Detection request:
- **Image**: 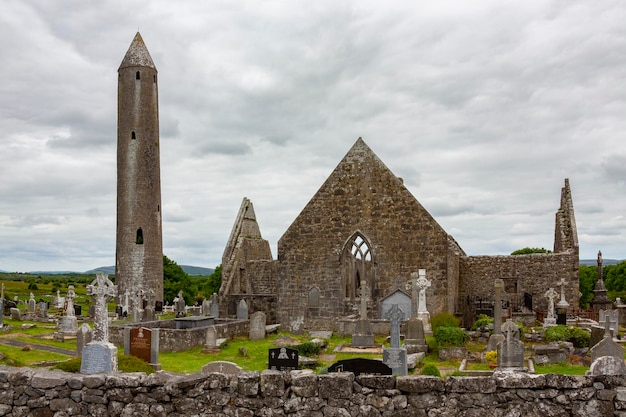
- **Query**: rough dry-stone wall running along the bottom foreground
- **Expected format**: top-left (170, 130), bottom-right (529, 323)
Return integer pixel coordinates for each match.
top-left (0, 367), bottom-right (626, 417)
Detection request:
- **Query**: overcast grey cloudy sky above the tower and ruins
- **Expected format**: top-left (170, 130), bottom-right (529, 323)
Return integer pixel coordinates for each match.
top-left (0, 0), bottom-right (626, 271)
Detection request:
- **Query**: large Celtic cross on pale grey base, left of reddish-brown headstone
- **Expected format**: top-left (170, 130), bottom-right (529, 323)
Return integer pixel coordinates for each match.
top-left (80, 274), bottom-right (117, 374)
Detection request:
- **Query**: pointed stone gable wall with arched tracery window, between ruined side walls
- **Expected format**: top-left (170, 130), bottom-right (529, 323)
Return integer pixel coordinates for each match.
top-left (278, 138), bottom-right (460, 324)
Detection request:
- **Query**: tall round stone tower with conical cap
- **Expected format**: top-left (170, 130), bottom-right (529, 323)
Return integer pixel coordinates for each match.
top-left (115, 33), bottom-right (163, 308)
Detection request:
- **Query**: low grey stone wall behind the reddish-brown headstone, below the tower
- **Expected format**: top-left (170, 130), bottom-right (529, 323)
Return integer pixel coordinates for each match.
top-left (109, 319), bottom-right (250, 352)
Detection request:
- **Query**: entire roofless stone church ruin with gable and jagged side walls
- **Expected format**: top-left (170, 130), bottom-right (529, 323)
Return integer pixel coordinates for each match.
top-left (220, 138), bottom-right (579, 331)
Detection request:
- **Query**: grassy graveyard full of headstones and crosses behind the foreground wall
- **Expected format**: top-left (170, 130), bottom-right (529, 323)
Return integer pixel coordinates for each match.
top-left (0, 275), bottom-right (624, 376)
